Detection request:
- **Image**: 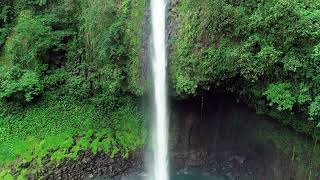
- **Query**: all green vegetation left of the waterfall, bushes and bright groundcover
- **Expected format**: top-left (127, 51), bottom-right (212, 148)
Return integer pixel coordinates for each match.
top-left (0, 0), bottom-right (146, 179)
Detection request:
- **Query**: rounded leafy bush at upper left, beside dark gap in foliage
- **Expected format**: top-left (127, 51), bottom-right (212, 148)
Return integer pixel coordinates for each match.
top-left (5, 11), bottom-right (65, 70)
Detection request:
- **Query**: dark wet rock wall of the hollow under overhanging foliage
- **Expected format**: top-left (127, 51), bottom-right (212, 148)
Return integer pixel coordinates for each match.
top-left (170, 94), bottom-right (312, 180)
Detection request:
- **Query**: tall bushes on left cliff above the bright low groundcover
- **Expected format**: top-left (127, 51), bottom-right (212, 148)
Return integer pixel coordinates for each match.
top-left (0, 0), bottom-right (145, 111)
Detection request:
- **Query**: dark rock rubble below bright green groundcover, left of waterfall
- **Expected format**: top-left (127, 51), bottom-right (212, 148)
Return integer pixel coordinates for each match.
top-left (34, 151), bottom-right (143, 180)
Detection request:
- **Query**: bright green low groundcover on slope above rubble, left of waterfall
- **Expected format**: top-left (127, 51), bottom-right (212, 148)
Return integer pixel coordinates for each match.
top-left (0, 97), bottom-right (146, 177)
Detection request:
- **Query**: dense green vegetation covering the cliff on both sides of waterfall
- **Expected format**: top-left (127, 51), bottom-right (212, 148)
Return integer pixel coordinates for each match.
top-left (0, 0), bottom-right (320, 179)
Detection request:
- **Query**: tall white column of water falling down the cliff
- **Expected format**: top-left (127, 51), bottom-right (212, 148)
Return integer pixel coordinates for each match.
top-left (151, 0), bottom-right (169, 180)
